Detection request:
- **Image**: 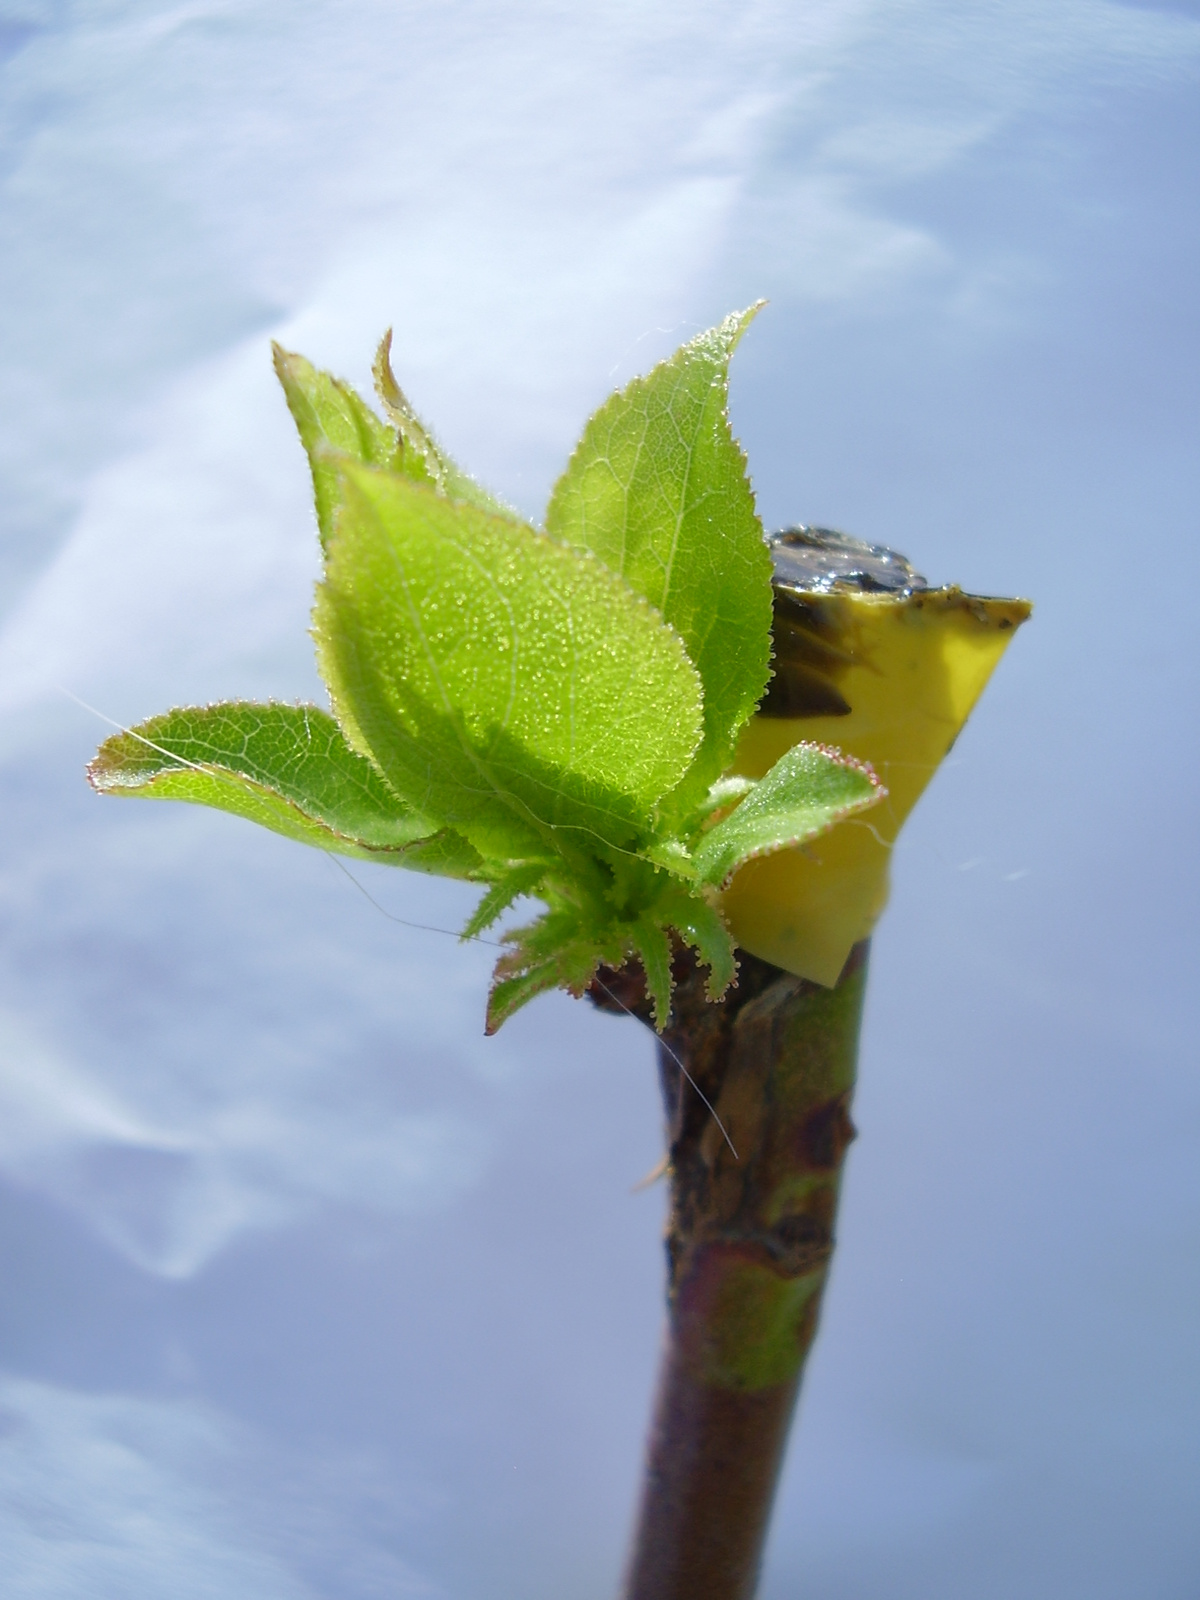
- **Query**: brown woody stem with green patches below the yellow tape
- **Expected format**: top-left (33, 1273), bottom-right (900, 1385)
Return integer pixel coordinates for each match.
top-left (594, 942), bottom-right (867, 1600)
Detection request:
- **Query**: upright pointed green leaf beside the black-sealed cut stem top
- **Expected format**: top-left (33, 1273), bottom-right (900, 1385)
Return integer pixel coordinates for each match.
top-left (546, 306), bottom-right (771, 806)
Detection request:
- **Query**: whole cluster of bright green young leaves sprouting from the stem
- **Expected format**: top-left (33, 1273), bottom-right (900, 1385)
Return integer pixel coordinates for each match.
top-left (90, 307), bottom-right (882, 1032)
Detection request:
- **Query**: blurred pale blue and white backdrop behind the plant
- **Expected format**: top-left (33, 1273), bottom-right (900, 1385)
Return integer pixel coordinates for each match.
top-left (0, 0), bottom-right (1200, 1600)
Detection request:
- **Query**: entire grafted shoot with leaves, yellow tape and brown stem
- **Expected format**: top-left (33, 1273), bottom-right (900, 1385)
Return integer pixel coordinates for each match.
top-left (88, 307), bottom-right (1029, 1600)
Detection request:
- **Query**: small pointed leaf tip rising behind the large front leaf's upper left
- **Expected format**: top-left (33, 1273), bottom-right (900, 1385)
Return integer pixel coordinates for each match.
top-left (270, 344), bottom-right (405, 547)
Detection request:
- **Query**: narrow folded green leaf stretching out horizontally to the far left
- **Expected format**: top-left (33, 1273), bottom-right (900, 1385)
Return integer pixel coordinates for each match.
top-left (88, 701), bottom-right (482, 877)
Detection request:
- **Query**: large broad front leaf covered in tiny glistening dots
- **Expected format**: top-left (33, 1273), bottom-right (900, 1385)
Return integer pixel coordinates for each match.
top-left (314, 464), bottom-right (701, 861)
